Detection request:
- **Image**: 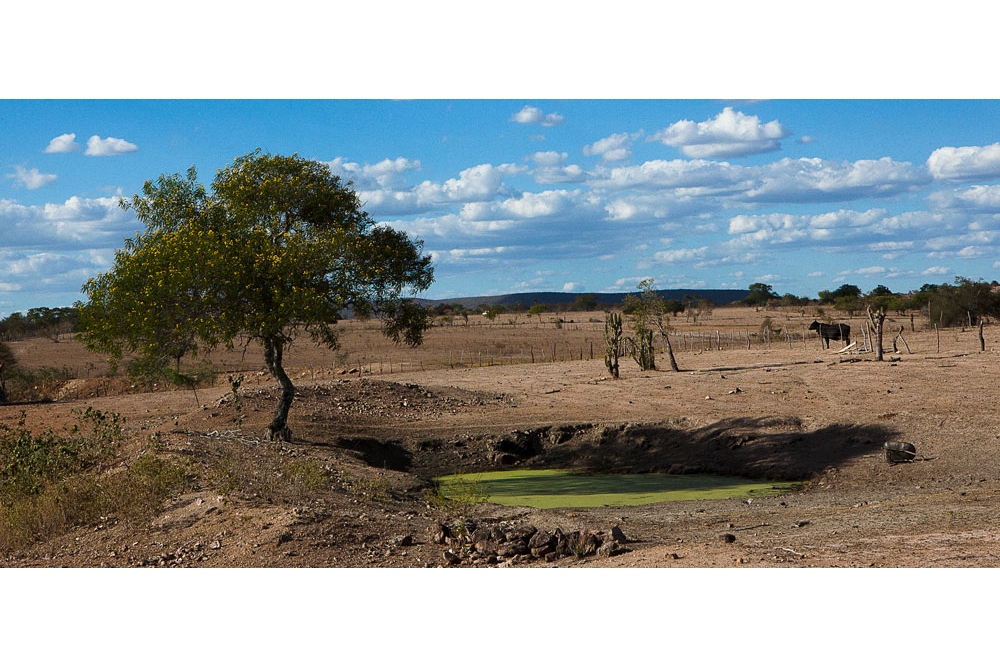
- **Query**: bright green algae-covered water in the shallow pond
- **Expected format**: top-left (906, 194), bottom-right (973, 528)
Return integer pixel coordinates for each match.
top-left (437, 470), bottom-right (799, 508)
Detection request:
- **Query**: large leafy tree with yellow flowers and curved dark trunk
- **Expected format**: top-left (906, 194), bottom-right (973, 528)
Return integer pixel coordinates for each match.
top-left (78, 150), bottom-right (433, 440)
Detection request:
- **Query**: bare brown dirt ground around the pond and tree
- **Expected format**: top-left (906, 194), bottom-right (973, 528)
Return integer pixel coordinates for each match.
top-left (0, 314), bottom-right (1000, 568)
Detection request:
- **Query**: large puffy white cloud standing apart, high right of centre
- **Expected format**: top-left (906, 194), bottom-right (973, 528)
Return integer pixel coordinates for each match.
top-left (649, 107), bottom-right (791, 158)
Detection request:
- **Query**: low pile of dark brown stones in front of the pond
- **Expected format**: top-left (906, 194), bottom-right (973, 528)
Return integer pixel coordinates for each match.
top-left (432, 519), bottom-right (628, 565)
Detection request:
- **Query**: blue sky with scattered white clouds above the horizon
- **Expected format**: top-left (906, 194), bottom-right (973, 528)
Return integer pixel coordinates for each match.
top-left (0, 99), bottom-right (1000, 316)
